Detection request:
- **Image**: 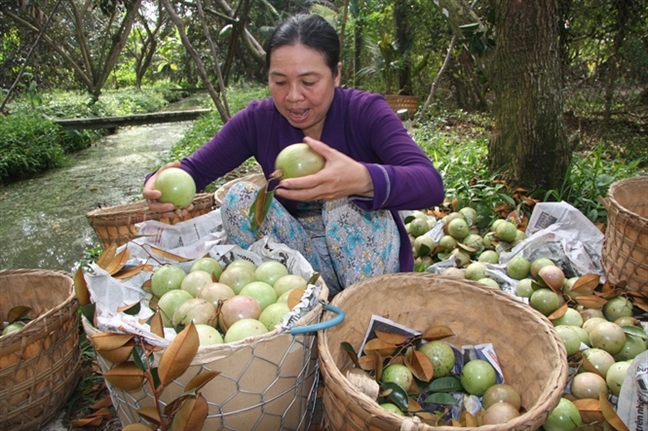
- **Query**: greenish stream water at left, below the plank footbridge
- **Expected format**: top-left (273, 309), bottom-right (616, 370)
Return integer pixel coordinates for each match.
top-left (0, 122), bottom-right (191, 271)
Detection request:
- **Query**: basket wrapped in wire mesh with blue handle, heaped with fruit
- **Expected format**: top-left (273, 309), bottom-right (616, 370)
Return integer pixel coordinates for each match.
top-left (83, 280), bottom-right (328, 431)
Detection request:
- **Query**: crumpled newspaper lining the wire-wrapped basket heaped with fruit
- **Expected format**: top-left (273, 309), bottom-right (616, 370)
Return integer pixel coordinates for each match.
top-left (85, 209), bottom-right (323, 347)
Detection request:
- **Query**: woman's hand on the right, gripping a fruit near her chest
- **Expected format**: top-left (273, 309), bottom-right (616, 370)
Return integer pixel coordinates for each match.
top-left (275, 138), bottom-right (373, 201)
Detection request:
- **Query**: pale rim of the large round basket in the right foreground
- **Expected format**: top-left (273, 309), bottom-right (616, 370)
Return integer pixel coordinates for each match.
top-left (317, 273), bottom-right (568, 431)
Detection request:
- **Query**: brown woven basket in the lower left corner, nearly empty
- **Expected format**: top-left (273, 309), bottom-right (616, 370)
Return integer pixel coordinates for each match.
top-left (0, 269), bottom-right (81, 431)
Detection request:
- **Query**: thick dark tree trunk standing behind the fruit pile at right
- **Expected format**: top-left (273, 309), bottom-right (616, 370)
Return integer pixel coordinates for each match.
top-left (489, 0), bottom-right (571, 189)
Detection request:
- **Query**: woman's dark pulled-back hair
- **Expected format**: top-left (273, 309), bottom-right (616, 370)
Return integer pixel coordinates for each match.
top-left (265, 13), bottom-right (340, 76)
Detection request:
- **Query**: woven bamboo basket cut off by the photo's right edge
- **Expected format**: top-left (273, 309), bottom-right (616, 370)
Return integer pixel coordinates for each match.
top-left (601, 176), bottom-right (648, 293)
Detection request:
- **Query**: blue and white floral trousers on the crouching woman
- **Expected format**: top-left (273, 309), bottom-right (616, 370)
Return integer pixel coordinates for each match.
top-left (221, 182), bottom-right (400, 296)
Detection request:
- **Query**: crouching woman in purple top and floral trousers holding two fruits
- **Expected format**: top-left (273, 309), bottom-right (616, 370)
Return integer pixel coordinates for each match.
top-left (143, 14), bottom-right (444, 294)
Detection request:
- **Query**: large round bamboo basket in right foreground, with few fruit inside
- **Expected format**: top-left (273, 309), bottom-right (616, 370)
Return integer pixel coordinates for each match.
top-left (318, 273), bottom-right (568, 431)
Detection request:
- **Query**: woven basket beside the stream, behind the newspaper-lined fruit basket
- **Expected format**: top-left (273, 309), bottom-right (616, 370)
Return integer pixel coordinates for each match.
top-left (86, 193), bottom-right (214, 250)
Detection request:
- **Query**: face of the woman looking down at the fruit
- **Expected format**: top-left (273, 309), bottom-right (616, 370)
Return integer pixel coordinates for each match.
top-left (268, 45), bottom-right (340, 139)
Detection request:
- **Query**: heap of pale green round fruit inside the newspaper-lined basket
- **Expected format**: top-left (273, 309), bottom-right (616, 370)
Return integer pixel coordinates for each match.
top-left (144, 257), bottom-right (308, 345)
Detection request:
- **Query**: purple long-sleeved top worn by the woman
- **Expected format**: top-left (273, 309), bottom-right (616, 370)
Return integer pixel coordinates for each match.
top-left (181, 87), bottom-right (444, 271)
